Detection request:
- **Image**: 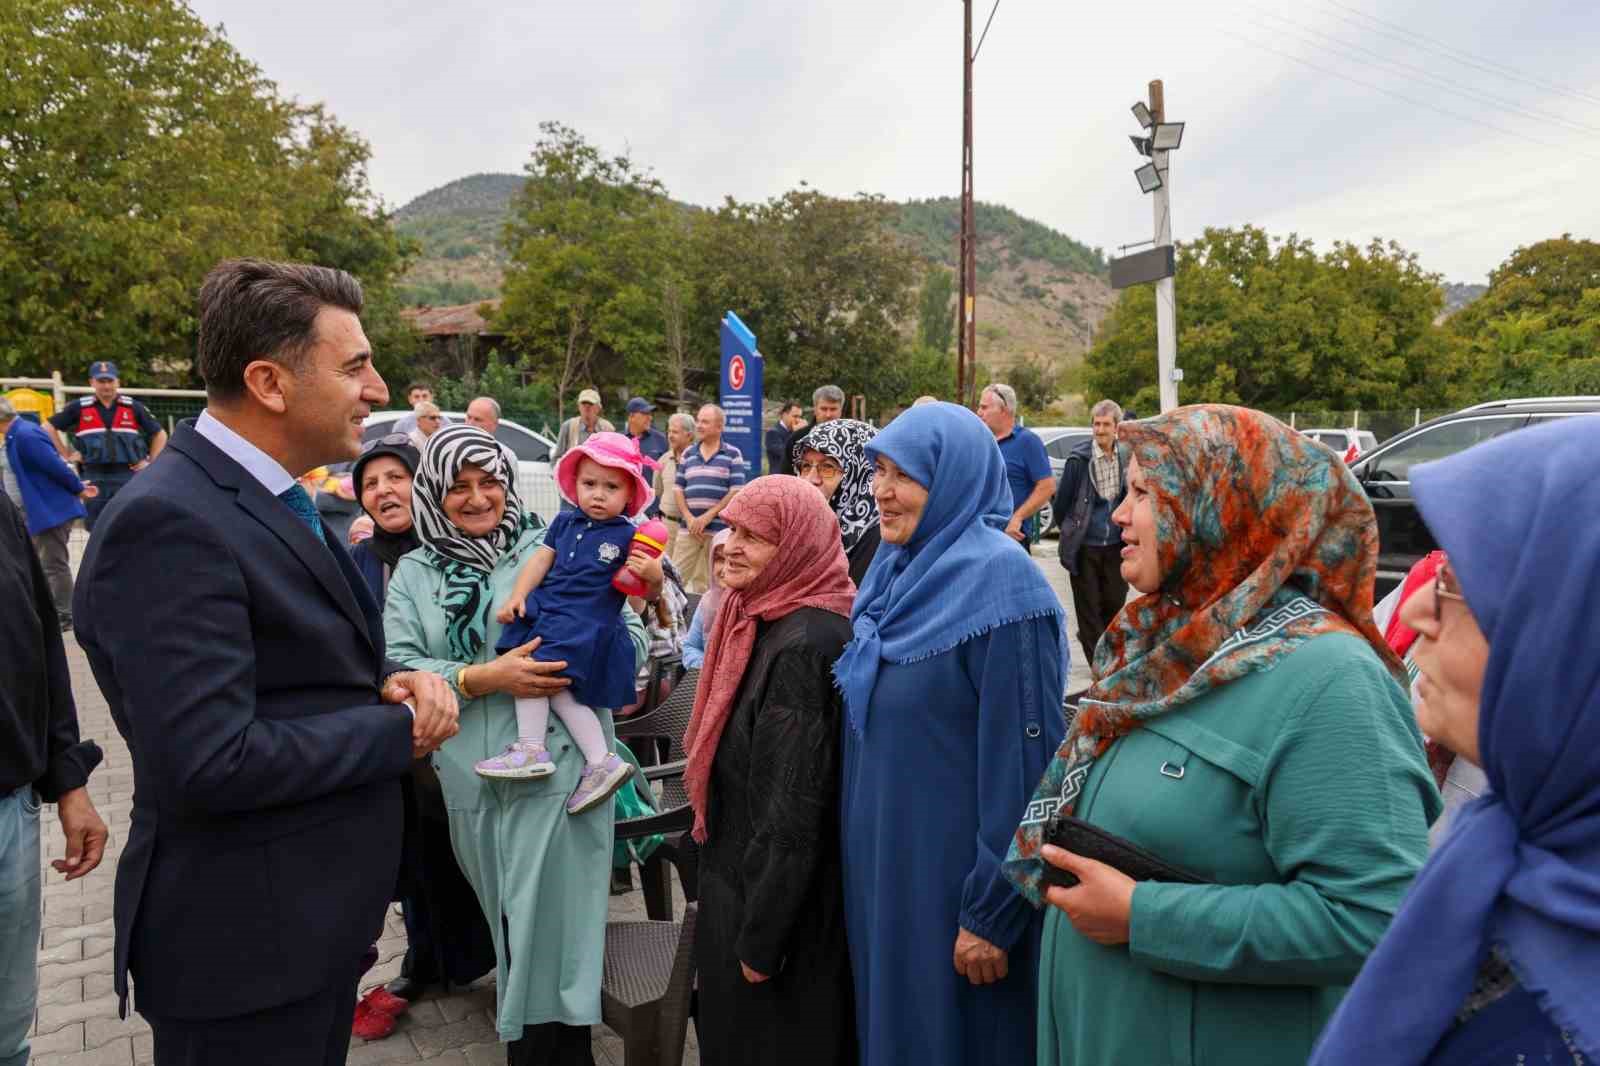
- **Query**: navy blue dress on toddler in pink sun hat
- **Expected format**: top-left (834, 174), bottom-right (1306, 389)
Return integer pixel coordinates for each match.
top-left (494, 511), bottom-right (637, 707)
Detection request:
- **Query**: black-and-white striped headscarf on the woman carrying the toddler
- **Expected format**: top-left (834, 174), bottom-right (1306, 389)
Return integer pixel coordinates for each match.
top-left (411, 426), bottom-right (538, 663)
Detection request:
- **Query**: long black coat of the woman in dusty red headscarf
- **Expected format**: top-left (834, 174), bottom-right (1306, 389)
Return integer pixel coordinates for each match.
top-left (694, 607), bottom-right (856, 1066)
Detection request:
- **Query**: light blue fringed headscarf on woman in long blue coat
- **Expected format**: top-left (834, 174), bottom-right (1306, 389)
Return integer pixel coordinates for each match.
top-left (834, 403), bottom-right (1067, 736)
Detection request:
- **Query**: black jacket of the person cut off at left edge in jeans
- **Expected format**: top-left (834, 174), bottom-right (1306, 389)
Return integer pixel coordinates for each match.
top-left (0, 493), bottom-right (101, 793)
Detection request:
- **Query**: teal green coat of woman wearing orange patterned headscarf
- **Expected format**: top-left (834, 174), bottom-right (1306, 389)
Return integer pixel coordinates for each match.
top-left (1038, 634), bottom-right (1440, 1066)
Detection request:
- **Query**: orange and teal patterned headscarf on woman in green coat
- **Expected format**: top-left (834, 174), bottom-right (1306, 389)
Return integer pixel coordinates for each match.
top-left (1003, 405), bottom-right (1405, 906)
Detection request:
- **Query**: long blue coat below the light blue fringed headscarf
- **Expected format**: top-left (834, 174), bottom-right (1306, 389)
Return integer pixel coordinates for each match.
top-left (842, 615), bottom-right (1066, 1066)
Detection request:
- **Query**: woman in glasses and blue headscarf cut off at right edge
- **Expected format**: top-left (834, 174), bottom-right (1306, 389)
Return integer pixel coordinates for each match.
top-left (1312, 418), bottom-right (1600, 1066)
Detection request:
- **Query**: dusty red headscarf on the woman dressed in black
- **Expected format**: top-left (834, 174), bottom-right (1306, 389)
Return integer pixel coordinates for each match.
top-left (683, 475), bottom-right (856, 842)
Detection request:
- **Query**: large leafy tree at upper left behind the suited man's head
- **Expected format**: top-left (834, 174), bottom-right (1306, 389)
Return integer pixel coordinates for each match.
top-left (0, 0), bottom-right (419, 383)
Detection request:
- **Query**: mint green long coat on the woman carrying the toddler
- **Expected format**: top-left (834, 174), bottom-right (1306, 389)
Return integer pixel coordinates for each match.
top-left (384, 530), bottom-right (646, 1040)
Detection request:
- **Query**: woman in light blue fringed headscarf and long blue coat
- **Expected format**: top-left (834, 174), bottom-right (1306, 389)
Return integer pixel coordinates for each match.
top-left (835, 403), bottom-right (1067, 1066)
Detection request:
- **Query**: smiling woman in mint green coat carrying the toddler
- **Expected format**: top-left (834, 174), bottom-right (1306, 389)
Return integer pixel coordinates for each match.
top-left (384, 426), bottom-right (645, 1066)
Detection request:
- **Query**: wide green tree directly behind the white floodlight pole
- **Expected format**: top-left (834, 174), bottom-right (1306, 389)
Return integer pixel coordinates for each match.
top-left (1085, 226), bottom-right (1453, 410)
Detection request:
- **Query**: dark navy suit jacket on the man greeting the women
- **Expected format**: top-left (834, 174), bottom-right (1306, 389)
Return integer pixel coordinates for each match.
top-left (74, 423), bottom-right (411, 1020)
